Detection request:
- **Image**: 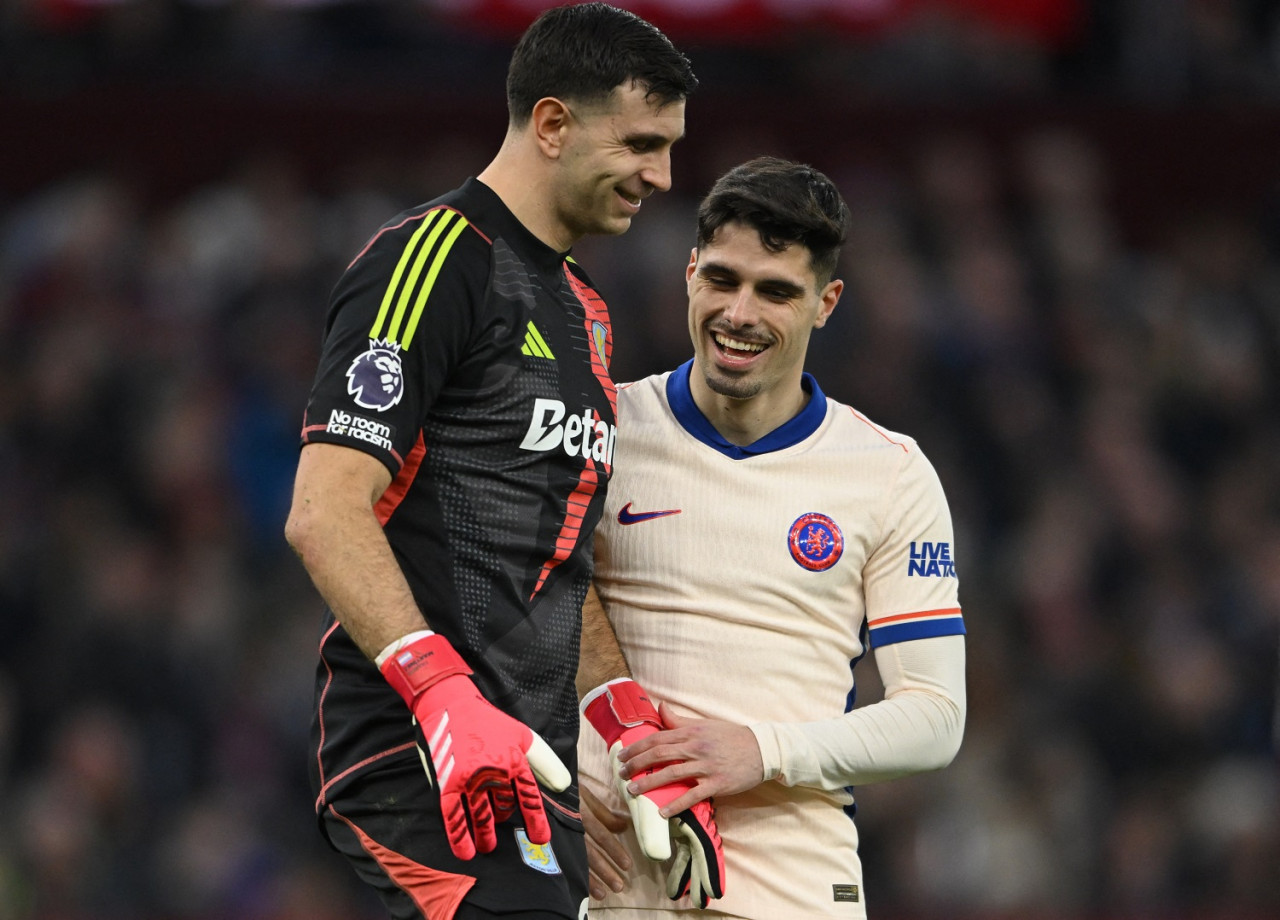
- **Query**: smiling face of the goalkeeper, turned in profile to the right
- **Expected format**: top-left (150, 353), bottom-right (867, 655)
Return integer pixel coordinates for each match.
top-left (552, 83), bottom-right (685, 242)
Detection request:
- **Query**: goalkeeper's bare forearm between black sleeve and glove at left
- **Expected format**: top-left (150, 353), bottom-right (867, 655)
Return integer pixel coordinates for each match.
top-left (284, 444), bottom-right (429, 660)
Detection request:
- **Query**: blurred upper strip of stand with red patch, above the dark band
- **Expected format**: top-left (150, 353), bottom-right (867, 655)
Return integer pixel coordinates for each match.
top-left (0, 0), bottom-right (1280, 101)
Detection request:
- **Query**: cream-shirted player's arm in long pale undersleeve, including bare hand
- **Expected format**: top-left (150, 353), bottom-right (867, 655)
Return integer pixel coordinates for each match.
top-left (618, 636), bottom-right (966, 813)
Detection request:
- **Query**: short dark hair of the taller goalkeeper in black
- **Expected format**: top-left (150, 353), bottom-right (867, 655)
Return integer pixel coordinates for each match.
top-left (507, 3), bottom-right (698, 125)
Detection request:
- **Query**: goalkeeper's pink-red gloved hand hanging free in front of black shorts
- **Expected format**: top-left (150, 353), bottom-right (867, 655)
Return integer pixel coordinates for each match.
top-left (378, 632), bottom-right (571, 860)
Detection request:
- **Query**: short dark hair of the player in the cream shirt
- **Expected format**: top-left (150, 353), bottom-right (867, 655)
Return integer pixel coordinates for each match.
top-left (698, 156), bottom-right (849, 287)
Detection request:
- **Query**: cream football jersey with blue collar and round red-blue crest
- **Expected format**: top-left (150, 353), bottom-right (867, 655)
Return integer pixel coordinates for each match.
top-left (579, 363), bottom-right (964, 917)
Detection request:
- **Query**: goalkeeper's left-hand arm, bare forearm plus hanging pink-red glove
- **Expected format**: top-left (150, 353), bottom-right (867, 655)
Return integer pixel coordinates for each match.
top-left (285, 444), bottom-right (572, 860)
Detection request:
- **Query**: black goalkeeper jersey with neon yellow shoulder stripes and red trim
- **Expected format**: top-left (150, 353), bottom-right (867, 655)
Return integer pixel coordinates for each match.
top-left (302, 179), bottom-right (616, 810)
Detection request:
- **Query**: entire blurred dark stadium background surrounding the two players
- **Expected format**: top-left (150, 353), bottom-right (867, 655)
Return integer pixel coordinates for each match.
top-left (0, 0), bottom-right (1280, 920)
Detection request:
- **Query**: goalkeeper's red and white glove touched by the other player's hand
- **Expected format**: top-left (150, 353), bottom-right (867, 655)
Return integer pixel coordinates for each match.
top-left (582, 678), bottom-right (724, 907)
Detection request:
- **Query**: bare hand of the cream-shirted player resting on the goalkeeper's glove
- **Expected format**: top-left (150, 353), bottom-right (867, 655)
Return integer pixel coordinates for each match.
top-left (617, 704), bottom-right (764, 816)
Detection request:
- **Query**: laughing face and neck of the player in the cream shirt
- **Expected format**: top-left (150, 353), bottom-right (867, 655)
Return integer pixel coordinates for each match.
top-left (686, 221), bottom-right (844, 440)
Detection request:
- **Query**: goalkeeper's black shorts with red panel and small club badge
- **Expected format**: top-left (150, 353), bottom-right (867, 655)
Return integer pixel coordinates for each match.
top-left (320, 759), bottom-right (588, 920)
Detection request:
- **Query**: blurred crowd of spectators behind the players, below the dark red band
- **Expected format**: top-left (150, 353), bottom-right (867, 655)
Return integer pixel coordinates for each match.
top-left (0, 3), bottom-right (1280, 920)
